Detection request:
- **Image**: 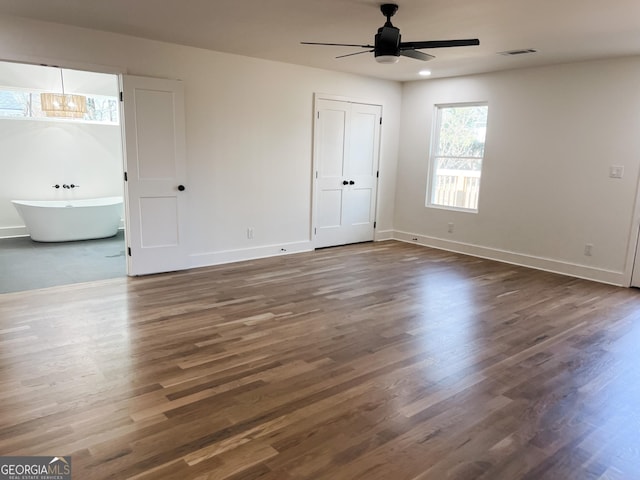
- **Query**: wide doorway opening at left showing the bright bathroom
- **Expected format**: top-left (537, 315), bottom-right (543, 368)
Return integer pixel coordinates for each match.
top-left (0, 62), bottom-right (127, 293)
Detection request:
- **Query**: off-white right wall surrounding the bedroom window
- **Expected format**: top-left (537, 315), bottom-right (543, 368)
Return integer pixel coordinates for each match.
top-left (395, 58), bottom-right (640, 284)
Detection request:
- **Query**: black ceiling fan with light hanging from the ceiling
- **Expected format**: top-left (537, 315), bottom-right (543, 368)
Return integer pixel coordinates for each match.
top-left (301, 3), bottom-right (480, 63)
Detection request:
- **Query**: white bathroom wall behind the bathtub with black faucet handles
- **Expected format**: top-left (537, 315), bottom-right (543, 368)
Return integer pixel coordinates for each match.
top-left (0, 118), bottom-right (123, 237)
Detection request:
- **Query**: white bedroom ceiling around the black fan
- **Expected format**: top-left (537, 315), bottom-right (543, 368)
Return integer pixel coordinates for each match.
top-left (0, 0), bottom-right (640, 81)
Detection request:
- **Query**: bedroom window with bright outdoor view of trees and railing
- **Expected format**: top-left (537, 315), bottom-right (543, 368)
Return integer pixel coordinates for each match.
top-left (427, 104), bottom-right (488, 212)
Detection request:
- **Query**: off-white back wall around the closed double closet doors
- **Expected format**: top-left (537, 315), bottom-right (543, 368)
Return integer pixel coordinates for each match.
top-left (0, 13), bottom-right (402, 265)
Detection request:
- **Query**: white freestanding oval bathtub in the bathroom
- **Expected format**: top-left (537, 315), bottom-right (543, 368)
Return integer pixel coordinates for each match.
top-left (11, 197), bottom-right (122, 242)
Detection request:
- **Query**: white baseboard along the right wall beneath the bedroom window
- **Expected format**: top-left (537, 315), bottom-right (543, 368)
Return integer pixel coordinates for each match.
top-left (393, 230), bottom-right (629, 287)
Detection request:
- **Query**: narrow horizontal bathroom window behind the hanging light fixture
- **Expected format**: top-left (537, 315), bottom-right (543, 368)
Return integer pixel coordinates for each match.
top-left (0, 90), bottom-right (119, 125)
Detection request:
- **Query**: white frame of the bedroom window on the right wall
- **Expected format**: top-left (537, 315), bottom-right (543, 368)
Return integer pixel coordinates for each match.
top-left (425, 101), bottom-right (489, 213)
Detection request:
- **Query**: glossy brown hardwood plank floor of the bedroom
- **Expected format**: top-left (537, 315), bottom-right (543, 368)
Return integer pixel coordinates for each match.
top-left (0, 242), bottom-right (640, 480)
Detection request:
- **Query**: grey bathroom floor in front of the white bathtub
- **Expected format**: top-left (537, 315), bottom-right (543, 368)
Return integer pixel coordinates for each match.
top-left (0, 230), bottom-right (126, 293)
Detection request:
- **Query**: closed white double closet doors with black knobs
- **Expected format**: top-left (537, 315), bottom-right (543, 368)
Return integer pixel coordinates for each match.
top-left (314, 99), bottom-right (382, 248)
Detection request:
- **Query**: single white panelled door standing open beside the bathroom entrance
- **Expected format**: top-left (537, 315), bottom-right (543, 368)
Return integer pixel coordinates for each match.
top-left (122, 75), bottom-right (188, 275)
